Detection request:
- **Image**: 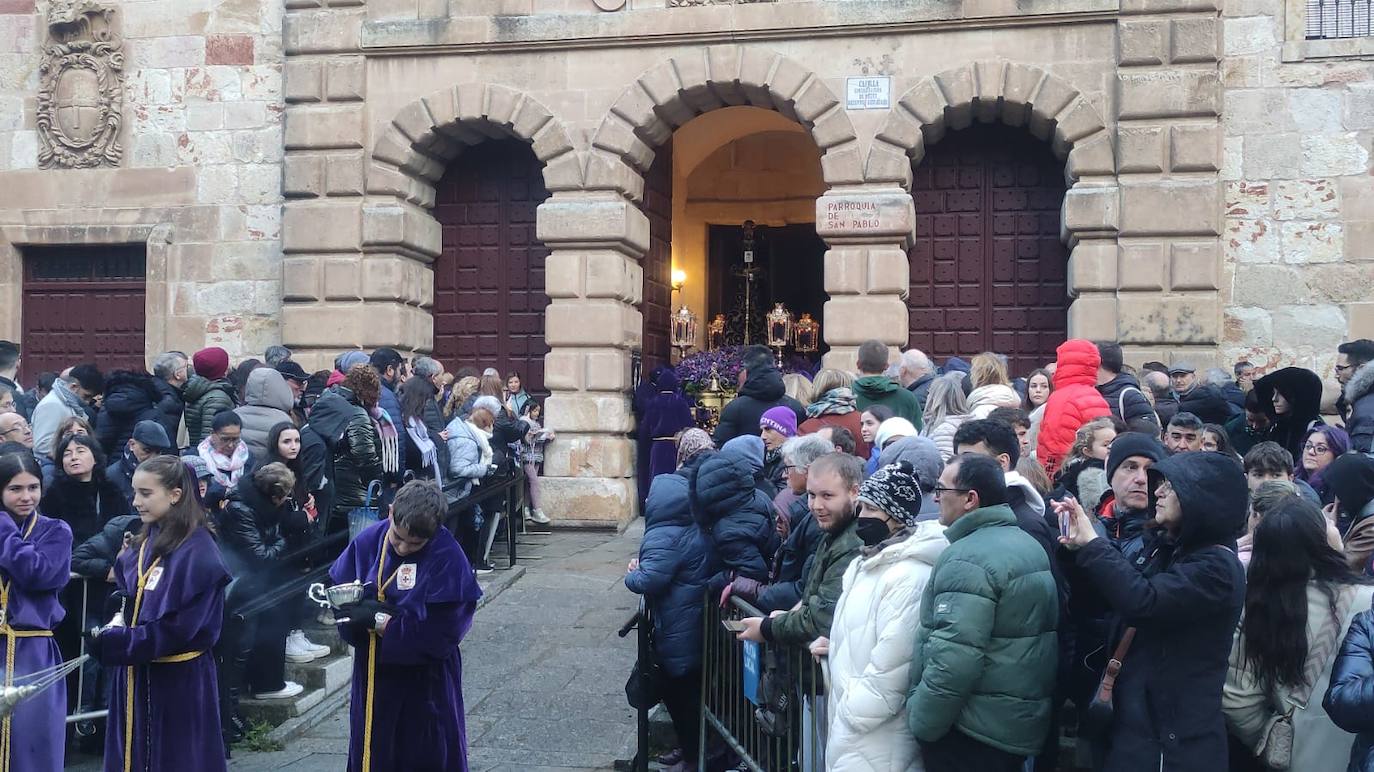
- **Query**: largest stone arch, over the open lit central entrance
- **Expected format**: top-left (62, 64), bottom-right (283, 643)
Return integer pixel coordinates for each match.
top-left (585, 45), bottom-right (863, 201)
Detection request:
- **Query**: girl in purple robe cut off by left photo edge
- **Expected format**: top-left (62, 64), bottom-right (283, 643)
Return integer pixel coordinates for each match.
top-left (0, 453), bottom-right (71, 772)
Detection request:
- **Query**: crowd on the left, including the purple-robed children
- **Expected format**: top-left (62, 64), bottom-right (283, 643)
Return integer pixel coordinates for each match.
top-left (0, 341), bottom-right (554, 771)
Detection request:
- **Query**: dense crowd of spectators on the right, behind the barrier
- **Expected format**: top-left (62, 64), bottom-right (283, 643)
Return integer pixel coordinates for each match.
top-left (625, 339), bottom-right (1374, 772)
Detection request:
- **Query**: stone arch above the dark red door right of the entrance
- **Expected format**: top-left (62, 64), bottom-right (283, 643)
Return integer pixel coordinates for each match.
top-left (864, 60), bottom-right (1116, 188)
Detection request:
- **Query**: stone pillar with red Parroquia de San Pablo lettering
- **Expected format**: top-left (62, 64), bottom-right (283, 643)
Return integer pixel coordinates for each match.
top-left (816, 185), bottom-right (916, 371)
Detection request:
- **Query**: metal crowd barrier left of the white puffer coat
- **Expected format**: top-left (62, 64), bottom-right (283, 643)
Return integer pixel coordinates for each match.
top-left (698, 593), bottom-right (827, 772)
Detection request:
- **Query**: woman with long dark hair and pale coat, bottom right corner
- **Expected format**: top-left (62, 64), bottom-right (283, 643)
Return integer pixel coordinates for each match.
top-left (1221, 496), bottom-right (1374, 771)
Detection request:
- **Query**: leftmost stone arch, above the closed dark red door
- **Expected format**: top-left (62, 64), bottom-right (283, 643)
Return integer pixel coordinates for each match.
top-left (367, 82), bottom-right (583, 207)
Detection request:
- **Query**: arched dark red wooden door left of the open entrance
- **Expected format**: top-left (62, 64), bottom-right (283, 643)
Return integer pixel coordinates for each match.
top-left (434, 140), bottom-right (548, 391)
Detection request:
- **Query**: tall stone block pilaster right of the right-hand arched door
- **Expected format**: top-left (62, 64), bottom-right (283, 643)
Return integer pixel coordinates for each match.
top-left (1110, 0), bottom-right (1221, 361)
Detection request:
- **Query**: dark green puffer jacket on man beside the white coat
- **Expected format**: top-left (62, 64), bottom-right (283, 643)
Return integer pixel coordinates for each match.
top-left (907, 504), bottom-right (1059, 756)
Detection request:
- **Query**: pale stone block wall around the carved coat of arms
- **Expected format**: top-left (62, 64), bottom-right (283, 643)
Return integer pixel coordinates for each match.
top-left (0, 0), bottom-right (283, 357)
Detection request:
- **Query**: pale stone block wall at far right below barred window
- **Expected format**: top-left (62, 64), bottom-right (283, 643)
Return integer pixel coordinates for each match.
top-left (1220, 0), bottom-right (1374, 376)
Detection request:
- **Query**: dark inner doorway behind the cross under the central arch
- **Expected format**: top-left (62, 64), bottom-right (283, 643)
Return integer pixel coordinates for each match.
top-left (706, 223), bottom-right (829, 360)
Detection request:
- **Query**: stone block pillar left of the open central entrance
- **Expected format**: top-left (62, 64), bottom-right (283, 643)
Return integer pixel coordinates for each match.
top-left (537, 191), bottom-right (649, 526)
